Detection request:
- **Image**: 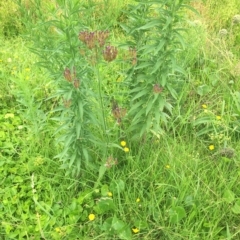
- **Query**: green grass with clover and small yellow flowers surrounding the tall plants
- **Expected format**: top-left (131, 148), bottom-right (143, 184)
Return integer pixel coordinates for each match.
top-left (0, 0), bottom-right (240, 240)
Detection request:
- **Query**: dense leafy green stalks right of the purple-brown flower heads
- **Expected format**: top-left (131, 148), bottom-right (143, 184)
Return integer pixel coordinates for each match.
top-left (122, 1), bottom-right (195, 138)
